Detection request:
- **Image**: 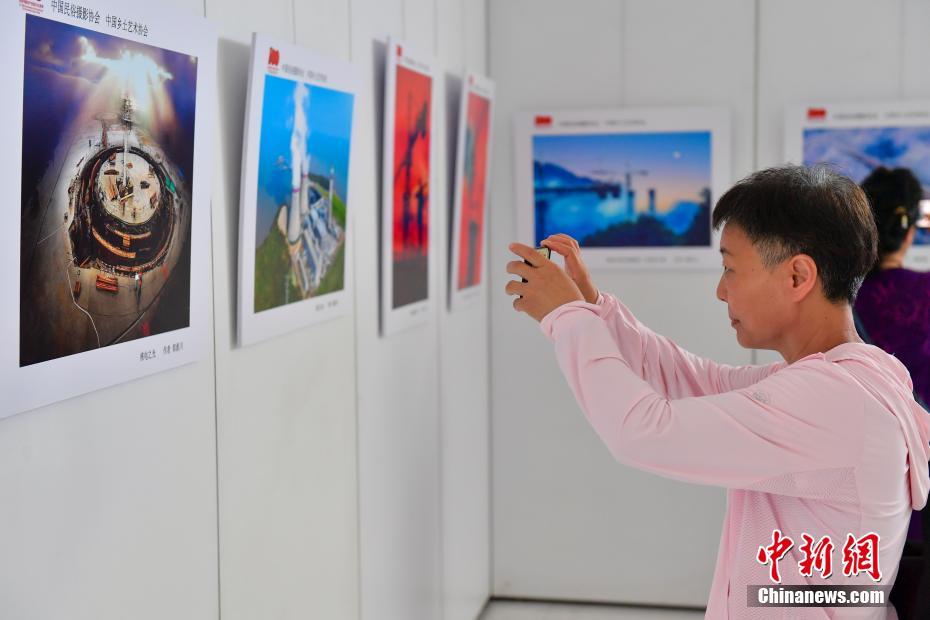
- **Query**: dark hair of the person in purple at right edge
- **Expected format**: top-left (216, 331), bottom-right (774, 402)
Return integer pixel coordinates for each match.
top-left (862, 166), bottom-right (923, 259)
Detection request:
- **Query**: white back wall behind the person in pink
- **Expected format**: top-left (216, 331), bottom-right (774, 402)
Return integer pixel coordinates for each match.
top-left (488, 0), bottom-right (930, 607)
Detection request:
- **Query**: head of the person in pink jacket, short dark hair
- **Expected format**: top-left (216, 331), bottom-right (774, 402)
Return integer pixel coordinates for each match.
top-left (713, 165), bottom-right (877, 350)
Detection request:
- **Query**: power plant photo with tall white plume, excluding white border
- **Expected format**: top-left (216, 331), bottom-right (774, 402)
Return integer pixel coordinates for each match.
top-left (254, 75), bottom-right (353, 312)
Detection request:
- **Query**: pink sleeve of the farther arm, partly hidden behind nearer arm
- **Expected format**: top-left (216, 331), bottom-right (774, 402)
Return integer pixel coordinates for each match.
top-left (588, 293), bottom-right (785, 398)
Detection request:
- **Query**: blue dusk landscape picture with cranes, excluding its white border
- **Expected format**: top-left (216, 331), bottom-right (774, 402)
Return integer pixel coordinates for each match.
top-left (533, 131), bottom-right (711, 248)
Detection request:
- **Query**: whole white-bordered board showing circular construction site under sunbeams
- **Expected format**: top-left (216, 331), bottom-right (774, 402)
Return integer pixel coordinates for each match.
top-left (0, 0), bottom-right (217, 417)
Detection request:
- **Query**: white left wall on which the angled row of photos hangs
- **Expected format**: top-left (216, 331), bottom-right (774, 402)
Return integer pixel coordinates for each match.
top-left (0, 0), bottom-right (490, 620)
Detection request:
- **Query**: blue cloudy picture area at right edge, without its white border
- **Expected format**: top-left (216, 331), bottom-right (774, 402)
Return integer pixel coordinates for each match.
top-left (804, 126), bottom-right (930, 245)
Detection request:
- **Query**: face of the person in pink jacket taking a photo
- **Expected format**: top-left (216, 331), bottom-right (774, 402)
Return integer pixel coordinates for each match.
top-left (717, 224), bottom-right (795, 350)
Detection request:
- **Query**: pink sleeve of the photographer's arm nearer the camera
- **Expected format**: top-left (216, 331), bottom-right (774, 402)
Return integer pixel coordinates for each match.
top-left (545, 302), bottom-right (864, 494)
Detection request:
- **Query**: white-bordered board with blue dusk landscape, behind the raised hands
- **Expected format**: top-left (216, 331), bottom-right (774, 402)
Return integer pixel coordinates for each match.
top-left (514, 107), bottom-right (730, 269)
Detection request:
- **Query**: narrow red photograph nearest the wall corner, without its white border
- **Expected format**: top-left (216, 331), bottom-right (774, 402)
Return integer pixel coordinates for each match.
top-left (456, 93), bottom-right (491, 290)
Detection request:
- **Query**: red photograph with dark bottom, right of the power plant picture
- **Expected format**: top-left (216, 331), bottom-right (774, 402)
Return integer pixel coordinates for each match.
top-left (391, 66), bottom-right (432, 308)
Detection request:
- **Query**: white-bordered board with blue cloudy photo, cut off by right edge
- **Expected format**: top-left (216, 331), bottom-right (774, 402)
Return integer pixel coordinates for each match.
top-left (785, 101), bottom-right (930, 270)
